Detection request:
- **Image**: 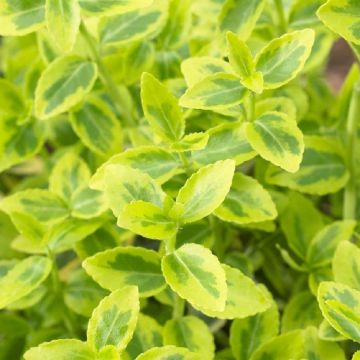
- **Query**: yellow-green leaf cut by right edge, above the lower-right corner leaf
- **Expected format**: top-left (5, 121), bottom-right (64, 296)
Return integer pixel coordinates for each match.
top-left (332, 240), bottom-right (360, 291)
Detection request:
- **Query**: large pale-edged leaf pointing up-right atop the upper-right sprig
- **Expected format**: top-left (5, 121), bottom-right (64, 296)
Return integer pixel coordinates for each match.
top-left (256, 29), bottom-right (315, 89)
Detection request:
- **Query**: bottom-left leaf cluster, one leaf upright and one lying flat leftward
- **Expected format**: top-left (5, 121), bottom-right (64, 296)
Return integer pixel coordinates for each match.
top-left (24, 286), bottom-right (140, 360)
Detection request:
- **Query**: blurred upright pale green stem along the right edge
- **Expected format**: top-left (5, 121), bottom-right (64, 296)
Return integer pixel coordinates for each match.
top-left (343, 82), bottom-right (360, 219)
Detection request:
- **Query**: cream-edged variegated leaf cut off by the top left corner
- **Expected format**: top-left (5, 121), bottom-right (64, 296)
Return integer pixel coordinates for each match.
top-left (0, 0), bottom-right (45, 36)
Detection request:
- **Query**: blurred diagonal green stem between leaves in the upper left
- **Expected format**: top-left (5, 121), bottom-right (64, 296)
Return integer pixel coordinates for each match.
top-left (80, 22), bottom-right (136, 127)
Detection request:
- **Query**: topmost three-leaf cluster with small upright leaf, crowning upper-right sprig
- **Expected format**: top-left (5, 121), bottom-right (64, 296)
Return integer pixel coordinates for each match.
top-left (180, 29), bottom-right (314, 110)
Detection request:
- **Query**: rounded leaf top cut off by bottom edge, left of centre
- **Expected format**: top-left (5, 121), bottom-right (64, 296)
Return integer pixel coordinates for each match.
top-left (136, 345), bottom-right (201, 360)
